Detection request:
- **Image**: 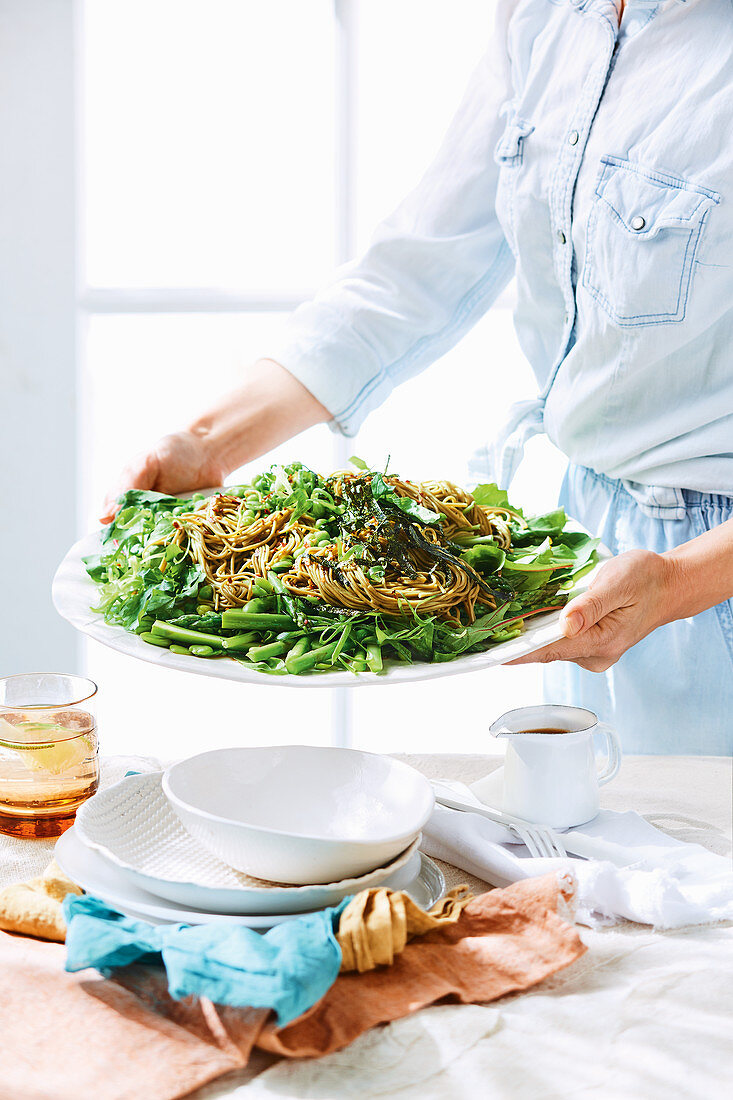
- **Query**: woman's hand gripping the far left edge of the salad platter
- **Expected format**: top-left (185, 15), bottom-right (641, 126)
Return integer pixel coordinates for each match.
top-left (99, 431), bottom-right (229, 524)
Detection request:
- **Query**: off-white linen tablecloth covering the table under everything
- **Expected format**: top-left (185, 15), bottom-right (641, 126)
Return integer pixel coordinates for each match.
top-left (0, 756), bottom-right (733, 1100)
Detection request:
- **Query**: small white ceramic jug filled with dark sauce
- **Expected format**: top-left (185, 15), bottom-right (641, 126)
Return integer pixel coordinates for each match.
top-left (489, 705), bottom-right (621, 828)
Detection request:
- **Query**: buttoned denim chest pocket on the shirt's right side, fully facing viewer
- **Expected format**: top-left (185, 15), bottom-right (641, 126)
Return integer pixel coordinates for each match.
top-left (582, 156), bottom-right (720, 328)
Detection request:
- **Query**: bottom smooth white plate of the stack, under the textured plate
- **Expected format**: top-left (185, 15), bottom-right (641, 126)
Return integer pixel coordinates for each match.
top-left (54, 826), bottom-right (446, 928)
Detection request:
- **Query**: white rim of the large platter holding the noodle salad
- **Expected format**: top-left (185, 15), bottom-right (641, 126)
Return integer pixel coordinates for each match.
top-left (52, 499), bottom-right (611, 688)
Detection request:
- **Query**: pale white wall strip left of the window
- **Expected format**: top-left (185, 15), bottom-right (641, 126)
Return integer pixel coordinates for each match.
top-left (0, 0), bottom-right (79, 675)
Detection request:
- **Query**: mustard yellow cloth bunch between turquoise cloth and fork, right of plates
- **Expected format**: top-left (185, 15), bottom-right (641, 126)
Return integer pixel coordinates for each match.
top-left (336, 886), bottom-right (473, 974)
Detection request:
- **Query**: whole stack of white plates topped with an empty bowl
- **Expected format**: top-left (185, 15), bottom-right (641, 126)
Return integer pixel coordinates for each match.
top-left (56, 745), bottom-right (445, 928)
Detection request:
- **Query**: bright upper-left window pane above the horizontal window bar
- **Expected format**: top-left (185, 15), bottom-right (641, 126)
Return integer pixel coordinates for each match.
top-left (84, 0), bottom-right (335, 289)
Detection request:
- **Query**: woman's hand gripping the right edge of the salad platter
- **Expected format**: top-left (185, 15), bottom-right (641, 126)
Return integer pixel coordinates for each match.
top-left (511, 550), bottom-right (676, 672)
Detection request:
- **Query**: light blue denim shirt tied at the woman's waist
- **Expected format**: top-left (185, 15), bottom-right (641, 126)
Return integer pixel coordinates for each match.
top-left (273, 0), bottom-right (733, 517)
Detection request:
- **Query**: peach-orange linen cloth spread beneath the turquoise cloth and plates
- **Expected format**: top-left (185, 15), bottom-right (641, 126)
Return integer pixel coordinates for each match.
top-left (0, 875), bottom-right (586, 1100)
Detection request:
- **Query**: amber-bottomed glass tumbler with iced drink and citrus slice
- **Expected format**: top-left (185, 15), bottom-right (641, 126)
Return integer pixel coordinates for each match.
top-left (0, 672), bottom-right (99, 837)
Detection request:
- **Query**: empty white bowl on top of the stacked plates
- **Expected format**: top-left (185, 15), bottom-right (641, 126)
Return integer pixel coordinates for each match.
top-left (163, 745), bottom-right (434, 884)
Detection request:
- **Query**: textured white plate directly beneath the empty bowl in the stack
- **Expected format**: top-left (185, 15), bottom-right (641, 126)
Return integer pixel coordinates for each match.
top-left (74, 772), bottom-right (420, 915)
